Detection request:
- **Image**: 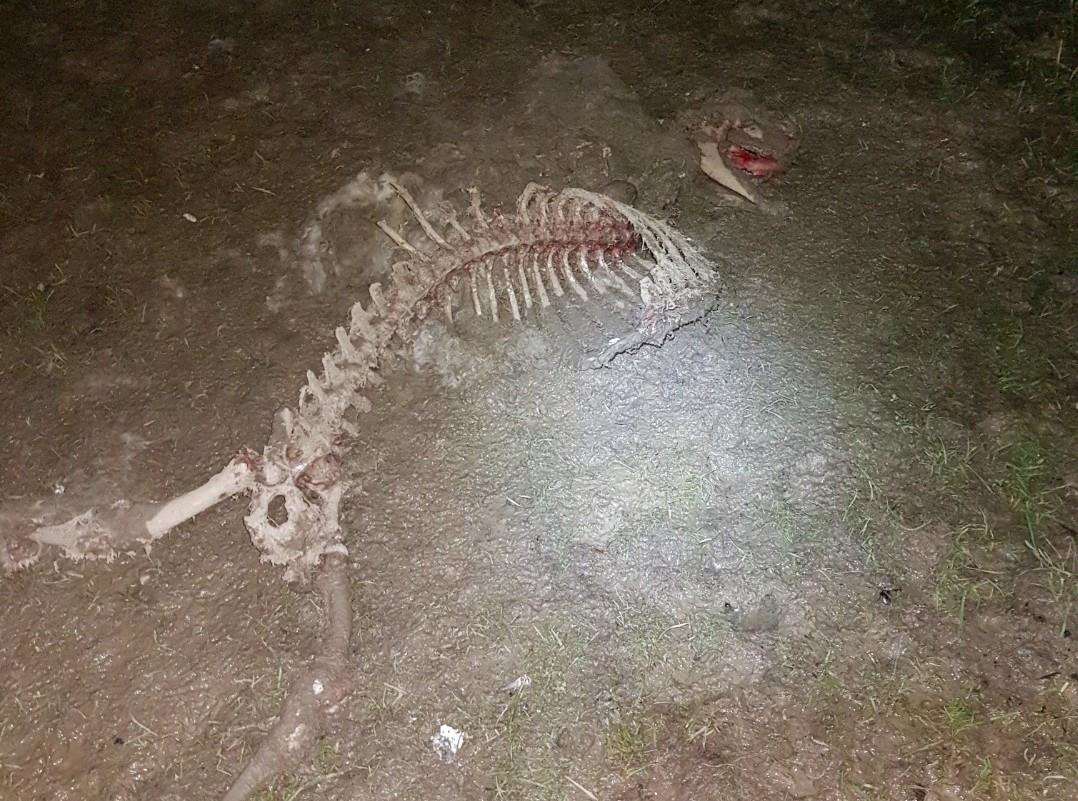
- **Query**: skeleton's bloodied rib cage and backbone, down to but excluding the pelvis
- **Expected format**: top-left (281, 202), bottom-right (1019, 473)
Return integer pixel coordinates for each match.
top-left (300, 178), bottom-right (714, 437)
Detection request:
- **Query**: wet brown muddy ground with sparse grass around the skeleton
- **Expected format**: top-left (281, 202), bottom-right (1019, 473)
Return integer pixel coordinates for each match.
top-left (0, 0), bottom-right (1078, 801)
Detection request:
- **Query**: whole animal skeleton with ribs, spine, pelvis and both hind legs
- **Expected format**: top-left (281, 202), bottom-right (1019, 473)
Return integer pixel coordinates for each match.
top-left (9, 176), bottom-right (717, 801)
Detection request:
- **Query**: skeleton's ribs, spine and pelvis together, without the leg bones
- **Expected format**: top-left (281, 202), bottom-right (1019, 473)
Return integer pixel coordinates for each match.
top-left (245, 176), bottom-right (715, 577)
